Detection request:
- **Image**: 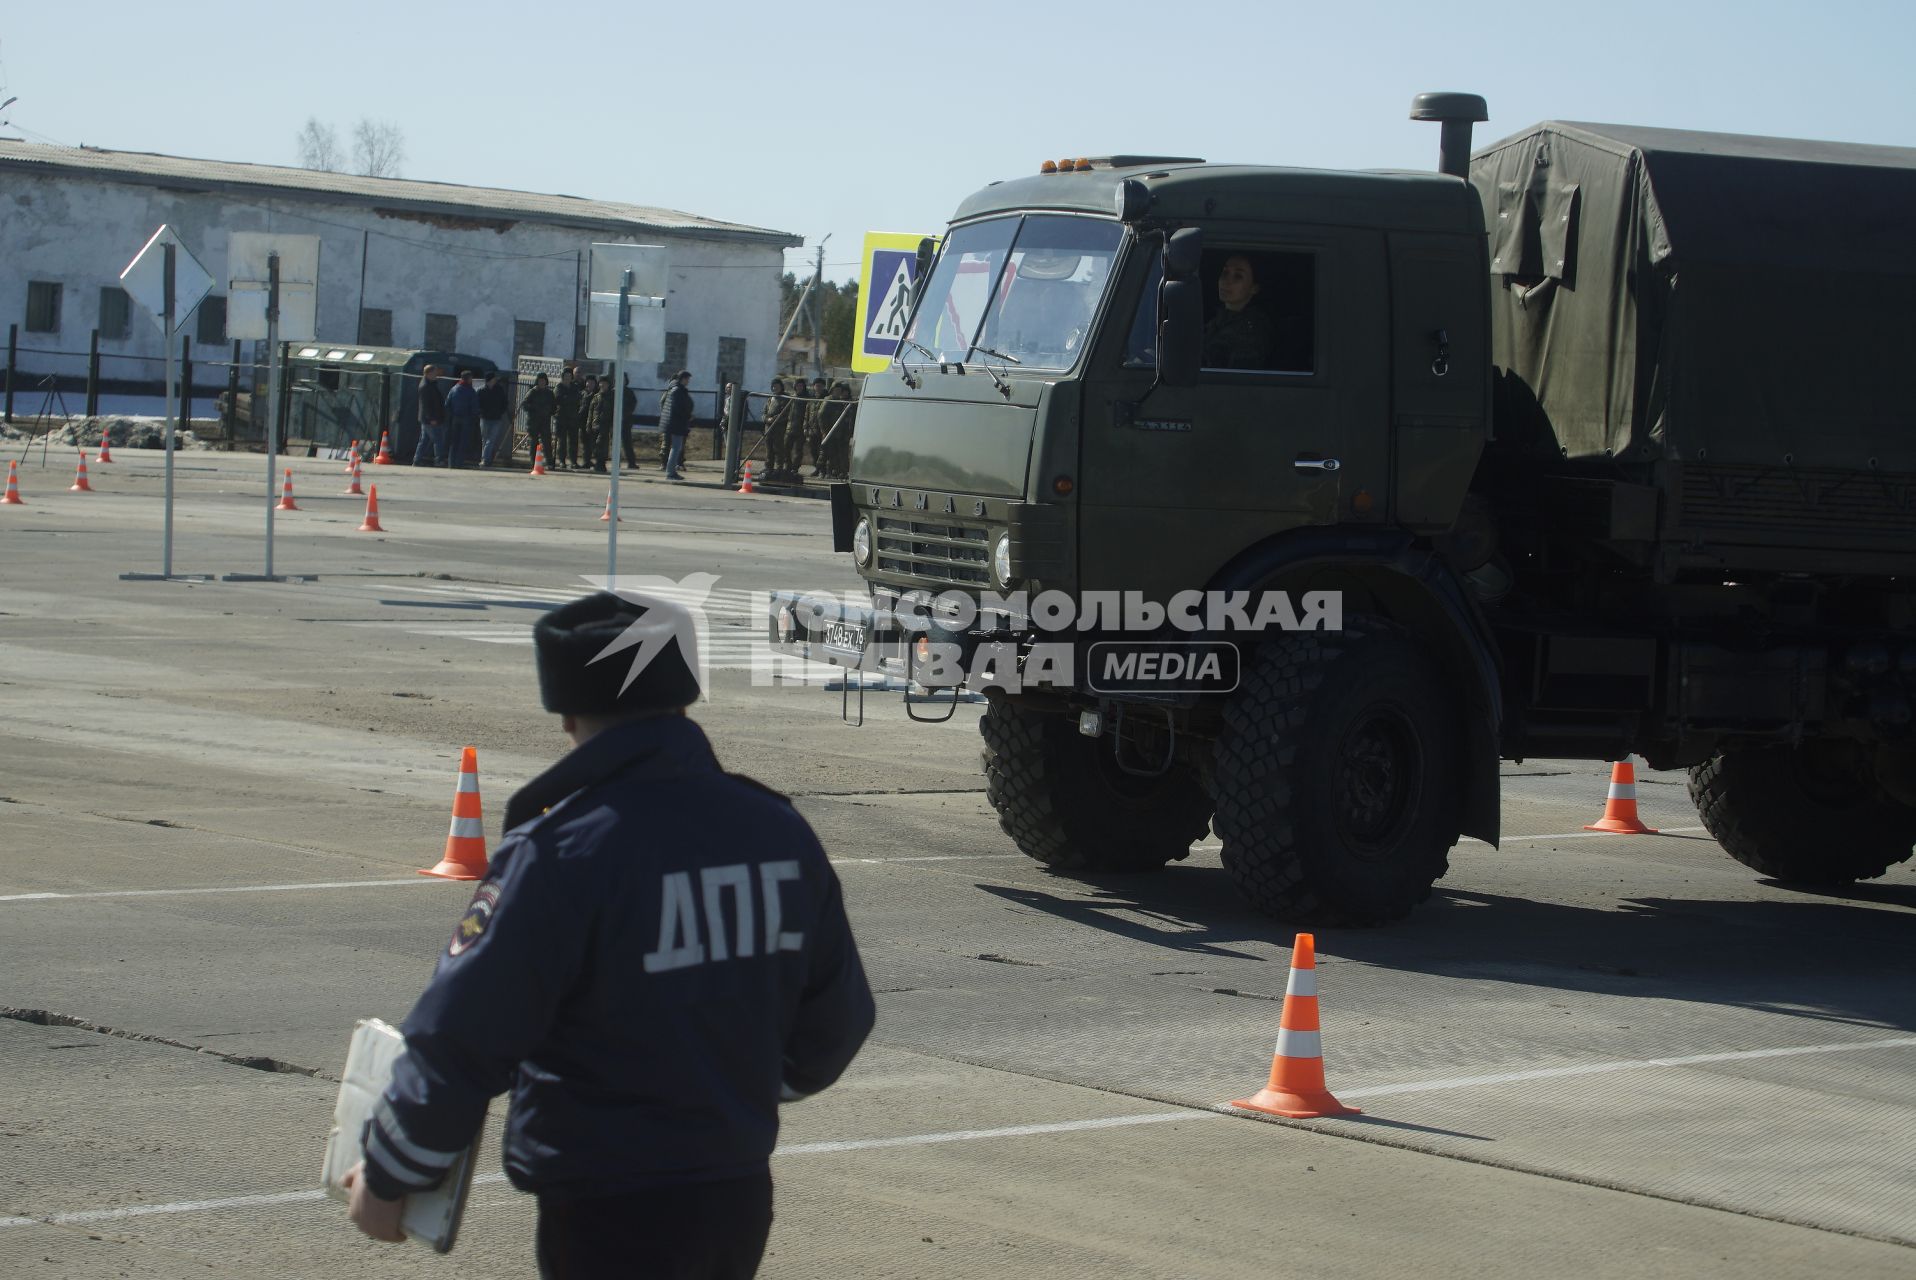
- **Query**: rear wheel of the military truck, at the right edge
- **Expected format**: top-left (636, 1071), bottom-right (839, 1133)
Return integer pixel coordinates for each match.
top-left (1690, 742), bottom-right (1916, 885)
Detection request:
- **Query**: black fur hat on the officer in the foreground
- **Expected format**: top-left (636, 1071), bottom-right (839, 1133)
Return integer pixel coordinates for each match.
top-left (533, 592), bottom-right (699, 715)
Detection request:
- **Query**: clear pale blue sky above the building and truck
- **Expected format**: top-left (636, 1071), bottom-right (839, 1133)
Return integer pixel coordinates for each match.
top-left (0, 0), bottom-right (1916, 280)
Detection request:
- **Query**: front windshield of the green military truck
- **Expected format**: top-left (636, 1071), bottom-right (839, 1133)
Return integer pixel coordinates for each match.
top-left (904, 213), bottom-right (1125, 370)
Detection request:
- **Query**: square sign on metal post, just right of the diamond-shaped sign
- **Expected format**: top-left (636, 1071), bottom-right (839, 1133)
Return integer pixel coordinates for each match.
top-left (224, 232), bottom-right (320, 583)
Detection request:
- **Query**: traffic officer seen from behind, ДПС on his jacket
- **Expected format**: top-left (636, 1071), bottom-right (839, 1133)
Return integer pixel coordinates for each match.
top-left (345, 592), bottom-right (874, 1276)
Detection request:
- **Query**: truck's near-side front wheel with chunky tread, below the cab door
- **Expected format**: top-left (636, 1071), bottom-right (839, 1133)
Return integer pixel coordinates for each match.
top-left (1213, 619), bottom-right (1462, 924)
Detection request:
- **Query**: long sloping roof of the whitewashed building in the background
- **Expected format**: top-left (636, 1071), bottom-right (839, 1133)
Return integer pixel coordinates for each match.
top-left (0, 138), bottom-right (805, 249)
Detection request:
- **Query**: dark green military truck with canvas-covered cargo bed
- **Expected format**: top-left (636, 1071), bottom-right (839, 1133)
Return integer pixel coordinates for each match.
top-left (768, 94), bottom-right (1916, 924)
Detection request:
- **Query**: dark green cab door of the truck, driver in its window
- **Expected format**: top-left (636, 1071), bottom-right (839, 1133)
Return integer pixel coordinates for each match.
top-left (1079, 226), bottom-right (1389, 594)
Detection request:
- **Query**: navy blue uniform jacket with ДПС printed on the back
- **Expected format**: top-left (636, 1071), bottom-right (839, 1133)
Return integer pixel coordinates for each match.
top-left (366, 715), bottom-right (874, 1200)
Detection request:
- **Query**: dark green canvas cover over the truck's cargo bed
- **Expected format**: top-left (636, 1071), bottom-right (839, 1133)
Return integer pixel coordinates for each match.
top-left (1470, 121), bottom-right (1916, 471)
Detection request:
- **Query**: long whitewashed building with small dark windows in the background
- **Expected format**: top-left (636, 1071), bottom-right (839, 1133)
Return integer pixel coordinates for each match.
top-left (0, 140), bottom-right (803, 400)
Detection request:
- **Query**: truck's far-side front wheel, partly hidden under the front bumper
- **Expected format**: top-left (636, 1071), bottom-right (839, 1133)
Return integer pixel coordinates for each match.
top-left (977, 696), bottom-right (1211, 872)
